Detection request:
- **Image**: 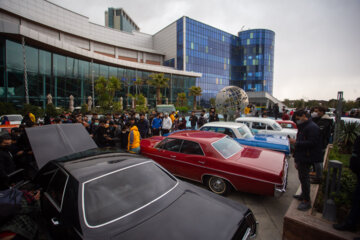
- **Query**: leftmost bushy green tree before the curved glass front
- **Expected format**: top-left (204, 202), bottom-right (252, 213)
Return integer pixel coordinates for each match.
top-left (95, 76), bottom-right (121, 110)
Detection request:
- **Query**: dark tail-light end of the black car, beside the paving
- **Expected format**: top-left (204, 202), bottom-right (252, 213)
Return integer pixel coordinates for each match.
top-left (232, 211), bottom-right (257, 240)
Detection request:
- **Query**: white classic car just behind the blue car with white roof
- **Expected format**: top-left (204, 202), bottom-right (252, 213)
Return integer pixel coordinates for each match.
top-left (235, 117), bottom-right (297, 139)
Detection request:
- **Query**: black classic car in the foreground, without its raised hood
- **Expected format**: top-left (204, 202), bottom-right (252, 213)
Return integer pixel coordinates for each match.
top-left (26, 124), bottom-right (257, 239)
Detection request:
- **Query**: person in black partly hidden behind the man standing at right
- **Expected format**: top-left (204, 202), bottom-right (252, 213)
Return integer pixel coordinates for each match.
top-left (311, 106), bottom-right (334, 184)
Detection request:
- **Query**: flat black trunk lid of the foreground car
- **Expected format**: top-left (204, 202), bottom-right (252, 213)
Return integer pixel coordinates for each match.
top-left (85, 182), bottom-right (249, 240)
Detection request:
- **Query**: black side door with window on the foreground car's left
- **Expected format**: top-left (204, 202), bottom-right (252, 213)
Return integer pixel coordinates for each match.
top-left (41, 167), bottom-right (69, 239)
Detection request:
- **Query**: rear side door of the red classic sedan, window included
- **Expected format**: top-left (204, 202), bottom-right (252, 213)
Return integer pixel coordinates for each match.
top-left (175, 140), bottom-right (207, 181)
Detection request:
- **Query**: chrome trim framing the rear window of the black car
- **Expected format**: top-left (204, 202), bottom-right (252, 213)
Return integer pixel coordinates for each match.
top-left (81, 161), bottom-right (179, 228)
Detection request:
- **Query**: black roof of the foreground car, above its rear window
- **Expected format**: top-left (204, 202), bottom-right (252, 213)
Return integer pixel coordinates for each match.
top-left (58, 152), bottom-right (152, 182)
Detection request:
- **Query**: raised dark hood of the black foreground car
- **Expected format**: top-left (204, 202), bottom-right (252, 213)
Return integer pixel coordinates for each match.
top-left (25, 123), bottom-right (97, 169)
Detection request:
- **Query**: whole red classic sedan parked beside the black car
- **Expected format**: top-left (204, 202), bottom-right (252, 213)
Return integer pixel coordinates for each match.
top-left (140, 131), bottom-right (288, 196)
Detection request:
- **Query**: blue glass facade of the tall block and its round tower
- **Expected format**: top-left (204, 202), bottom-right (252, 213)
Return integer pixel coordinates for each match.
top-left (176, 17), bottom-right (275, 105)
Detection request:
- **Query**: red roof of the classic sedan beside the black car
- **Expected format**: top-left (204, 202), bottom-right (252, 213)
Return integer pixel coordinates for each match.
top-left (169, 130), bottom-right (227, 143)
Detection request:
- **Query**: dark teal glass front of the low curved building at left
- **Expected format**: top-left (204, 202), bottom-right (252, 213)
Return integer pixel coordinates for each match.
top-left (0, 38), bottom-right (196, 107)
